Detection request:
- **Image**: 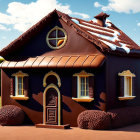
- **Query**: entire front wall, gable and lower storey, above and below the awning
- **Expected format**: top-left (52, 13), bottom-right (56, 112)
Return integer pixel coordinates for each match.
top-left (2, 11), bottom-right (106, 126)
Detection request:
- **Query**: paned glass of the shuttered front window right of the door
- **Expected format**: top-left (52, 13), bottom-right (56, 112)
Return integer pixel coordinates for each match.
top-left (79, 77), bottom-right (89, 97)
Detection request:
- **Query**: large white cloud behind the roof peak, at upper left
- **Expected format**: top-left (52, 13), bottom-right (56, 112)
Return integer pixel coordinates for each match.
top-left (0, 0), bottom-right (89, 32)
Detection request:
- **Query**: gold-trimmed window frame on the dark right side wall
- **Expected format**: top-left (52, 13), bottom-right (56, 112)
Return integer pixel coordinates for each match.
top-left (118, 70), bottom-right (136, 100)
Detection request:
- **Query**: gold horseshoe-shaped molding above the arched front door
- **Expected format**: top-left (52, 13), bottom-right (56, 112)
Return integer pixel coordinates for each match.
top-left (43, 71), bottom-right (61, 87)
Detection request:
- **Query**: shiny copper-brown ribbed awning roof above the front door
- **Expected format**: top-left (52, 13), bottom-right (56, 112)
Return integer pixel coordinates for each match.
top-left (0, 55), bottom-right (105, 68)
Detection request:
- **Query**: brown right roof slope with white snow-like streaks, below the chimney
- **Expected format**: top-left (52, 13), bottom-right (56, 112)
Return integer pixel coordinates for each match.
top-left (72, 15), bottom-right (140, 53)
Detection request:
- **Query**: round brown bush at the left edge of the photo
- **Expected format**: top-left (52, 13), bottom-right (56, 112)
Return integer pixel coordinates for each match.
top-left (0, 105), bottom-right (24, 125)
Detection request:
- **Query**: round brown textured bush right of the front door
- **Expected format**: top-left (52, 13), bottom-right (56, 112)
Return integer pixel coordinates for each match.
top-left (77, 110), bottom-right (111, 130)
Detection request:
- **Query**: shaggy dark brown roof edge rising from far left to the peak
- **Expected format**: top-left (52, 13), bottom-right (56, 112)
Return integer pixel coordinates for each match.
top-left (0, 10), bottom-right (69, 57)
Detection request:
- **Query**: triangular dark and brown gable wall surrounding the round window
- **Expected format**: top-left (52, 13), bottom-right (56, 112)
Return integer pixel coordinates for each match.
top-left (0, 9), bottom-right (102, 61)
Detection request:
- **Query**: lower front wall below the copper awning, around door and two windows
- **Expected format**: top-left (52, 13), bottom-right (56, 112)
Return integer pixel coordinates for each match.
top-left (2, 66), bottom-right (105, 126)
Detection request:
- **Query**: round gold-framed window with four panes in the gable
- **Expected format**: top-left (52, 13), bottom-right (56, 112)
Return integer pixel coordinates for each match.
top-left (46, 26), bottom-right (67, 49)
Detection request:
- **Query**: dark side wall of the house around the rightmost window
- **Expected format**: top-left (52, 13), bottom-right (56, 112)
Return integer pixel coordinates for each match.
top-left (106, 55), bottom-right (140, 109)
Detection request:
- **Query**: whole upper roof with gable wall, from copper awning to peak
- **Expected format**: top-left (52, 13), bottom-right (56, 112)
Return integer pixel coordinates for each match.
top-left (0, 10), bottom-right (140, 60)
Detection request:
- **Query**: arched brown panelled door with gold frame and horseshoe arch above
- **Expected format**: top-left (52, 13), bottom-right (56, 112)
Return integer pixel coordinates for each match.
top-left (43, 71), bottom-right (61, 125)
